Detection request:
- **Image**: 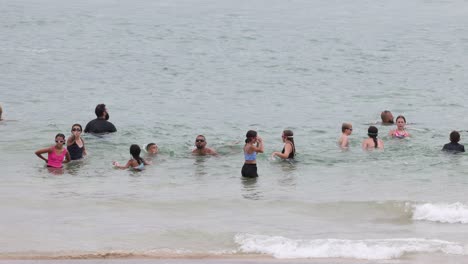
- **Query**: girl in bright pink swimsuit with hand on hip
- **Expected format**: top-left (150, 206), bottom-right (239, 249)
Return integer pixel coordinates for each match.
top-left (36, 133), bottom-right (70, 168)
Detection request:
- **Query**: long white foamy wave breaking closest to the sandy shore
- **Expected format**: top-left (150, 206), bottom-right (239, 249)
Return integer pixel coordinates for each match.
top-left (234, 234), bottom-right (467, 260)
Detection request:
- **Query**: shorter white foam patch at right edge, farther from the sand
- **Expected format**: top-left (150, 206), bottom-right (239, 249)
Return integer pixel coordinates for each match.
top-left (413, 203), bottom-right (468, 224)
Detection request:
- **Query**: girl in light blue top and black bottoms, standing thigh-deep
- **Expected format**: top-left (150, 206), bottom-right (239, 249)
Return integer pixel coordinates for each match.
top-left (241, 130), bottom-right (264, 178)
